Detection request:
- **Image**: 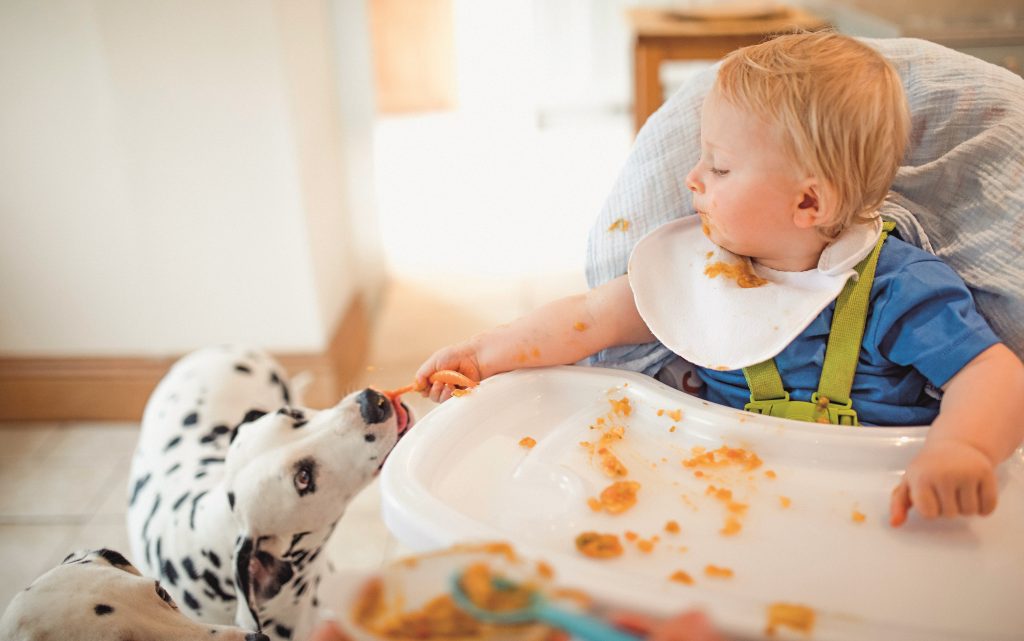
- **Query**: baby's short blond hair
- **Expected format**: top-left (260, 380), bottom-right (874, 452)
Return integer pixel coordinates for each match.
top-left (715, 31), bottom-right (910, 239)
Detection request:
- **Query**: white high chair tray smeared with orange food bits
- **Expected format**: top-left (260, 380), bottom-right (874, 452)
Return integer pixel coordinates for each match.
top-left (382, 368), bottom-right (1024, 641)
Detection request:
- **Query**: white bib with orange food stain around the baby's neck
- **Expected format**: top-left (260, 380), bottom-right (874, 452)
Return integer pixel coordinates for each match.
top-left (629, 216), bottom-right (882, 370)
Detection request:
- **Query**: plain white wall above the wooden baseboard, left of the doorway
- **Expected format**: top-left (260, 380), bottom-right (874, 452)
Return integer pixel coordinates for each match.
top-left (0, 0), bottom-right (379, 355)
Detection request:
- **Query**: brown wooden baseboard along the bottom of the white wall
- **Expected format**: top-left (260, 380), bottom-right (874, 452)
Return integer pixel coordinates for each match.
top-left (0, 295), bottom-right (370, 421)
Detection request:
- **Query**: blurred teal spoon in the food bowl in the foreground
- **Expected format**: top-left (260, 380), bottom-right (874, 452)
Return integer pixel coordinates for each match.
top-left (452, 572), bottom-right (641, 641)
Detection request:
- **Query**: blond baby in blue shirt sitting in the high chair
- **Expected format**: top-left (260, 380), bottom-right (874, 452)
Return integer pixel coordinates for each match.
top-left (416, 32), bottom-right (1024, 525)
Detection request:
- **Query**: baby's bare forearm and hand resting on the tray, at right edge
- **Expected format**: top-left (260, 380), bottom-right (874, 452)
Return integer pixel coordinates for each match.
top-left (890, 343), bottom-right (1024, 525)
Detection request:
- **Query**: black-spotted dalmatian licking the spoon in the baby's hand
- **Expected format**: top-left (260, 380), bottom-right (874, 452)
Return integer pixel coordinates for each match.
top-left (128, 347), bottom-right (411, 641)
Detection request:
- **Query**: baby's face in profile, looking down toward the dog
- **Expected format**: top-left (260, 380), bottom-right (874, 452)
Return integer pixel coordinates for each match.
top-left (686, 90), bottom-right (805, 269)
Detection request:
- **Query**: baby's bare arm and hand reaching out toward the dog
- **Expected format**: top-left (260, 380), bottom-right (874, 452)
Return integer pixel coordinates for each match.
top-left (416, 275), bottom-right (654, 401)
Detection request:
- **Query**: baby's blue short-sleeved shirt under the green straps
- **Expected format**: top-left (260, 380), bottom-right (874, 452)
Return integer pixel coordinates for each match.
top-left (697, 236), bottom-right (999, 425)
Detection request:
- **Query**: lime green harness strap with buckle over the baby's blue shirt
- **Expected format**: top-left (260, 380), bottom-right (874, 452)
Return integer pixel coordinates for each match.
top-left (743, 222), bottom-right (896, 425)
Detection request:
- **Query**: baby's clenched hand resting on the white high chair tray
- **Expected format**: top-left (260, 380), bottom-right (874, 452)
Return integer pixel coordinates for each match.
top-left (890, 439), bottom-right (997, 527)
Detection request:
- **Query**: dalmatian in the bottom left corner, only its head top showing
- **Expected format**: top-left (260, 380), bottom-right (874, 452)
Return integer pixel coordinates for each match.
top-left (0, 550), bottom-right (267, 641)
